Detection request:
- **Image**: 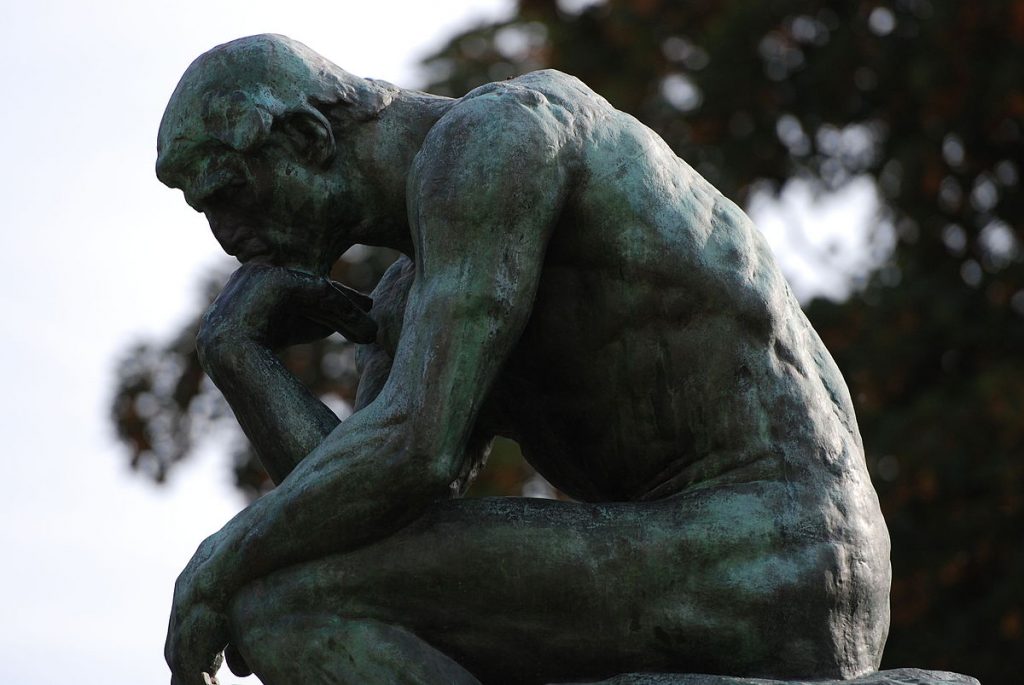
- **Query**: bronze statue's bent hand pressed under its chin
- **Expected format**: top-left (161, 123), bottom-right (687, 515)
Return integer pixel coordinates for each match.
top-left (198, 262), bottom-right (377, 353)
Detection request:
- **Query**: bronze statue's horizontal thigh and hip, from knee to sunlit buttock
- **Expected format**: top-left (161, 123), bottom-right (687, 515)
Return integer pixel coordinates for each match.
top-left (232, 482), bottom-right (888, 683)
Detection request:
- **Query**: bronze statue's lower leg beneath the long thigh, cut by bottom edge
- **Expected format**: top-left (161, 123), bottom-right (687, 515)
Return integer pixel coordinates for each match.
top-left (234, 605), bottom-right (480, 685)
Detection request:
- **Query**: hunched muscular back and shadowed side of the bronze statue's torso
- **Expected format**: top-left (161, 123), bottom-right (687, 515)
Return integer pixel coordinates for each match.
top-left (370, 71), bottom-right (866, 501)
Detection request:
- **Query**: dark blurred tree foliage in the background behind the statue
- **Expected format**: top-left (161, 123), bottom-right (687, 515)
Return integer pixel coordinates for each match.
top-left (113, 0), bottom-right (1024, 684)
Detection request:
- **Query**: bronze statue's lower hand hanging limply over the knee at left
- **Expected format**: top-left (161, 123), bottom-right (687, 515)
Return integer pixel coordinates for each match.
top-left (164, 538), bottom-right (227, 685)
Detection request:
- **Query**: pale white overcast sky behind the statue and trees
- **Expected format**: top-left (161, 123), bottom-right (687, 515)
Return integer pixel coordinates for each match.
top-left (0, 0), bottom-right (871, 685)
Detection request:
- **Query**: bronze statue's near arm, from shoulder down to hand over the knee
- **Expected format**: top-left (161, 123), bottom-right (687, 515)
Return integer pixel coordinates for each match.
top-left (167, 100), bottom-right (566, 684)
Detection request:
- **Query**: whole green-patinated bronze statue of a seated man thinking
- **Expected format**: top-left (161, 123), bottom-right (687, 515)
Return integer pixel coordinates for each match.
top-left (157, 36), bottom-right (974, 685)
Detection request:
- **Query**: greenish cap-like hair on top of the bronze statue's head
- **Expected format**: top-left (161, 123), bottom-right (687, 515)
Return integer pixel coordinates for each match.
top-left (157, 34), bottom-right (397, 166)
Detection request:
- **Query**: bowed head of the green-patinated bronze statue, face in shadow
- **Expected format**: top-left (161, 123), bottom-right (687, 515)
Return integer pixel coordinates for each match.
top-left (157, 35), bottom-right (394, 264)
